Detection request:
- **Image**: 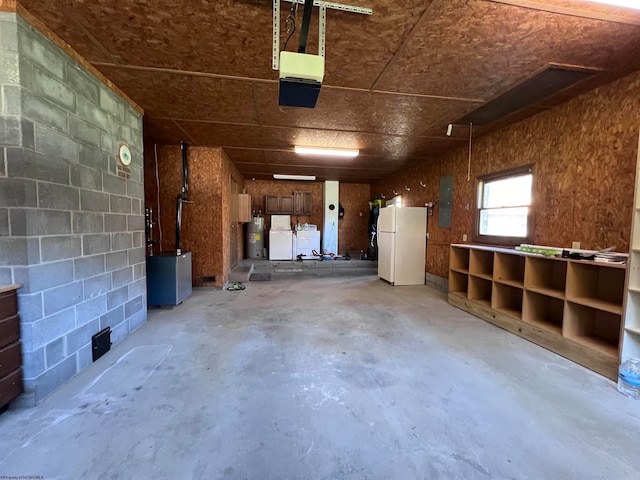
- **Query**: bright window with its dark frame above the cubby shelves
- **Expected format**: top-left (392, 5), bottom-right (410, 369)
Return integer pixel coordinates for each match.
top-left (474, 165), bottom-right (533, 245)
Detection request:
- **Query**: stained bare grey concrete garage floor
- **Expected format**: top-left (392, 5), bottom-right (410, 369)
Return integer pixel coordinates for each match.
top-left (0, 267), bottom-right (640, 480)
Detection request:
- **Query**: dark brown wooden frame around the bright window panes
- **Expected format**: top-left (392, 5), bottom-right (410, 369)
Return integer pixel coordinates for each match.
top-left (473, 163), bottom-right (536, 246)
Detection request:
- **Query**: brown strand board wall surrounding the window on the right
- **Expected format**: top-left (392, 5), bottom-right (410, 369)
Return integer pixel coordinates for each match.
top-left (371, 68), bottom-right (640, 276)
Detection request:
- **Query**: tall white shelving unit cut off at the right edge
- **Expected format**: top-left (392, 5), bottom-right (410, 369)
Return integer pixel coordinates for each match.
top-left (620, 131), bottom-right (640, 362)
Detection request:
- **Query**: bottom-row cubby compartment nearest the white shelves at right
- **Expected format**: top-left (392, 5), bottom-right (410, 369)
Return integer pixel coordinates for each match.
top-left (562, 301), bottom-right (622, 358)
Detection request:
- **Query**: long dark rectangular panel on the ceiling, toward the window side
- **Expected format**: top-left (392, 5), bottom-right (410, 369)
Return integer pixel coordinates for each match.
top-left (455, 65), bottom-right (598, 127)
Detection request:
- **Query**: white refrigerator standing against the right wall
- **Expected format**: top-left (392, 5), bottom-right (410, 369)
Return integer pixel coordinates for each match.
top-left (377, 207), bottom-right (427, 285)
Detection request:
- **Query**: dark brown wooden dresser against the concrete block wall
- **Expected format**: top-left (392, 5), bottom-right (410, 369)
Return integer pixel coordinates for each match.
top-left (0, 285), bottom-right (23, 412)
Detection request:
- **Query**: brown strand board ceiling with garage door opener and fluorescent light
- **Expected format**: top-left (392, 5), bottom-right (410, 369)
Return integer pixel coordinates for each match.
top-left (16, 0), bottom-right (640, 183)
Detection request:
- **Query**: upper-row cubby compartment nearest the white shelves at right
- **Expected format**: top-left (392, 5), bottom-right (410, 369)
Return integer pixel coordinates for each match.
top-left (566, 262), bottom-right (625, 315)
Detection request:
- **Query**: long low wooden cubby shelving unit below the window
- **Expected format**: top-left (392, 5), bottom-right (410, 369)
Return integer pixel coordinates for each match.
top-left (449, 246), bottom-right (624, 379)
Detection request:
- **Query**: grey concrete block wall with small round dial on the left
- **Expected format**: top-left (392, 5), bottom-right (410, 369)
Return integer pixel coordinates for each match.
top-left (0, 12), bottom-right (147, 405)
